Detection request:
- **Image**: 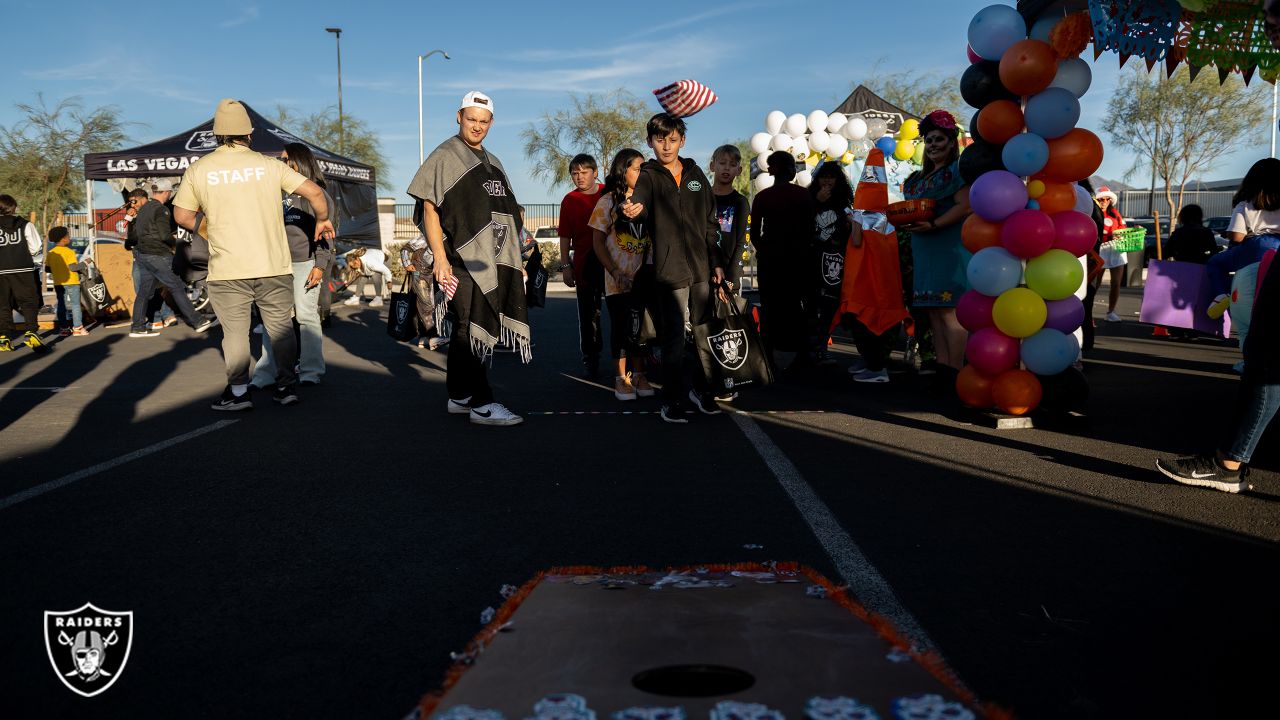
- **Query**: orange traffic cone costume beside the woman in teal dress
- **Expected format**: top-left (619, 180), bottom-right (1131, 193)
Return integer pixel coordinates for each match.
top-left (832, 149), bottom-right (909, 334)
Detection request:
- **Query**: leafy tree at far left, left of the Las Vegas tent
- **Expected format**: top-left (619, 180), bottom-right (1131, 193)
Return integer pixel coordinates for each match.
top-left (0, 95), bottom-right (125, 231)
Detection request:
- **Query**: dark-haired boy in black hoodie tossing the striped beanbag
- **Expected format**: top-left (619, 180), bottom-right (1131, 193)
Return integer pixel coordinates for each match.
top-left (620, 113), bottom-right (726, 423)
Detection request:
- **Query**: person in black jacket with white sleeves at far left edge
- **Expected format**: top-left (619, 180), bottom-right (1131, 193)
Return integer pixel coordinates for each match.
top-left (0, 195), bottom-right (47, 352)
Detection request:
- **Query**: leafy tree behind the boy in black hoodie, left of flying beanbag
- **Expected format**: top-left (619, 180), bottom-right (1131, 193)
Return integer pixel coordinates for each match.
top-left (520, 88), bottom-right (653, 188)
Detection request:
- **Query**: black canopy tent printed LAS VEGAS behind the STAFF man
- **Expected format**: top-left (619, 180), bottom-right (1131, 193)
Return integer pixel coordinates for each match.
top-left (84, 99), bottom-right (381, 247)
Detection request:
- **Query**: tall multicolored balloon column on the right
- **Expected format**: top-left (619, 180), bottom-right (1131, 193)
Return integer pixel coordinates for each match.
top-left (956, 5), bottom-right (1102, 415)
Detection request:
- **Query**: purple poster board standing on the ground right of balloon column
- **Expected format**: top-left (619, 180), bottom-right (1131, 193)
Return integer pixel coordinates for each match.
top-left (1139, 260), bottom-right (1231, 337)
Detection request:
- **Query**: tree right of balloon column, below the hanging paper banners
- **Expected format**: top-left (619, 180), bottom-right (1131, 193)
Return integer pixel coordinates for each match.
top-left (1102, 65), bottom-right (1268, 226)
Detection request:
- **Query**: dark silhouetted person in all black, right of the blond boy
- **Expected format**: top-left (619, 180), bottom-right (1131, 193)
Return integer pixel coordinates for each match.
top-left (750, 150), bottom-right (815, 370)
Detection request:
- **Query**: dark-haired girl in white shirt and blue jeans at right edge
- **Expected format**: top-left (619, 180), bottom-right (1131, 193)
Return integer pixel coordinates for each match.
top-left (1206, 158), bottom-right (1280, 319)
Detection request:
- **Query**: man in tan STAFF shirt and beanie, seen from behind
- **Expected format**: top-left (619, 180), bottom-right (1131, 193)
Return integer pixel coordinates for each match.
top-left (173, 100), bottom-right (334, 410)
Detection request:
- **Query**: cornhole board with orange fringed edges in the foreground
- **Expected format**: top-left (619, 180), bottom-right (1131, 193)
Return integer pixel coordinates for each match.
top-left (411, 566), bottom-right (991, 720)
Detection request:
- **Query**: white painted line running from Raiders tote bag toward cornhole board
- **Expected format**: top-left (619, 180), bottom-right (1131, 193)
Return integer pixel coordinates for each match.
top-left (730, 413), bottom-right (936, 650)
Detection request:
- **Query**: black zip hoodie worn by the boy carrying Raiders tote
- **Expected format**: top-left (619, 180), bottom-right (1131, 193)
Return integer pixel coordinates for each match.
top-left (618, 158), bottom-right (726, 290)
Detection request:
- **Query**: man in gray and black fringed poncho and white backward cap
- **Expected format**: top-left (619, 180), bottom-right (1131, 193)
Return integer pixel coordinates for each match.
top-left (408, 92), bottom-right (531, 425)
